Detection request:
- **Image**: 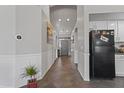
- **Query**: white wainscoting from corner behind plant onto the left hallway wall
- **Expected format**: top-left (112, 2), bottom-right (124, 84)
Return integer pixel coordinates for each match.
top-left (15, 49), bottom-right (54, 87)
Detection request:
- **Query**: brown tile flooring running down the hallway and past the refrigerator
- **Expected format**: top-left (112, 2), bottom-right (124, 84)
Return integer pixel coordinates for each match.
top-left (23, 57), bottom-right (124, 88)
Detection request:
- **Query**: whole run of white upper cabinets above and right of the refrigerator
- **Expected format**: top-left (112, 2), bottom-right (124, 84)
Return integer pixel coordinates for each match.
top-left (90, 21), bottom-right (124, 42)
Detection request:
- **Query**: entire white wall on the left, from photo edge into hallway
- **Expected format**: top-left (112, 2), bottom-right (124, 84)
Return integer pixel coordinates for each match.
top-left (0, 5), bottom-right (55, 87)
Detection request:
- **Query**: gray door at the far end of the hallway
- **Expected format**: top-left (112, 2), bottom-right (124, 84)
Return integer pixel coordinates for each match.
top-left (61, 40), bottom-right (69, 56)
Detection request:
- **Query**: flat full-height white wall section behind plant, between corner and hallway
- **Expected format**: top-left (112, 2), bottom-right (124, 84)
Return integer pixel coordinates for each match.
top-left (15, 6), bottom-right (42, 87)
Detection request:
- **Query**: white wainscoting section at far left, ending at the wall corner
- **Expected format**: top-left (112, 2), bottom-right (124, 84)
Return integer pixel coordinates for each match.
top-left (0, 55), bottom-right (15, 88)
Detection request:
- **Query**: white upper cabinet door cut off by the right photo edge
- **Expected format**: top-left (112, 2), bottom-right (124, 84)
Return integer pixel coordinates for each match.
top-left (118, 21), bottom-right (124, 42)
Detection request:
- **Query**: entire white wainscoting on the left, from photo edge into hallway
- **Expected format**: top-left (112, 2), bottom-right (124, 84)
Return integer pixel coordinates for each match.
top-left (0, 49), bottom-right (59, 88)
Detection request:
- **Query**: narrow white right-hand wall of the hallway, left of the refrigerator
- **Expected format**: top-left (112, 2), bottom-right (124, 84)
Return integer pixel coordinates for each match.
top-left (77, 6), bottom-right (87, 80)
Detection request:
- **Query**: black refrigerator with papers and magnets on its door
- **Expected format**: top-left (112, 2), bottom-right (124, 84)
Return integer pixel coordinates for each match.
top-left (89, 30), bottom-right (115, 79)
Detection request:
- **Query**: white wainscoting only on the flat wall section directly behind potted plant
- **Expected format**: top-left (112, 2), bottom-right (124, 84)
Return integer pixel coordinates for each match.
top-left (15, 54), bottom-right (42, 87)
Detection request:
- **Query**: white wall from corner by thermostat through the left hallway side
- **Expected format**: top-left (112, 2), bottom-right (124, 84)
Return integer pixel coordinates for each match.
top-left (15, 6), bottom-right (55, 87)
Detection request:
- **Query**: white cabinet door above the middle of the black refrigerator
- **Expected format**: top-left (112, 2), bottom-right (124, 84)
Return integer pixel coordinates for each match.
top-left (95, 21), bottom-right (107, 30)
